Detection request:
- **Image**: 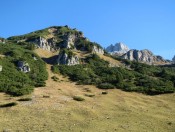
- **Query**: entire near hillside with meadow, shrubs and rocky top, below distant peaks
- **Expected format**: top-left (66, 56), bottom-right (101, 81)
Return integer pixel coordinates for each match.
top-left (0, 26), bottom-right (175, 132)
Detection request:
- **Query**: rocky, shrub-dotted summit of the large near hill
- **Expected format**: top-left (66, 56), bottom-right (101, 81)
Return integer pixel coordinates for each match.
top-left (8, 25), bottom-right (104, 65)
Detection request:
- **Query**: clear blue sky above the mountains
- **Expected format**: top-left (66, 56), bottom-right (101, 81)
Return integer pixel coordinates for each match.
top-left (0, 0), bottom-right (175, 59)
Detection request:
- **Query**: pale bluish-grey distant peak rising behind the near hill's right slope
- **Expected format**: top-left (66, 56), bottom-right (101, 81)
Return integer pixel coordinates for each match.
top-left (106, 43), bottom-right (129, 56)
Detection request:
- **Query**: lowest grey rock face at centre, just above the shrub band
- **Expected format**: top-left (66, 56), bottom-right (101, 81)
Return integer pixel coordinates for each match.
top-left (57, 53), bottom-right (80, 65)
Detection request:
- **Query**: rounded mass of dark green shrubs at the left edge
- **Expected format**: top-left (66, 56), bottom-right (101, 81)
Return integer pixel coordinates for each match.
top-left (0, 43), bottom-right (48, 96)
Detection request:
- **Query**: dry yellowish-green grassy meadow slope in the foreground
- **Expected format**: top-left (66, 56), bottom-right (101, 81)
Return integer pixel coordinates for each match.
top-left (0, 50), bottom-right (175, 132)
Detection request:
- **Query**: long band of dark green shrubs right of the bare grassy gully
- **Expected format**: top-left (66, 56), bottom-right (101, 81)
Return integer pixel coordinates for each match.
top-left (52, 54), bottom-right (175, 95)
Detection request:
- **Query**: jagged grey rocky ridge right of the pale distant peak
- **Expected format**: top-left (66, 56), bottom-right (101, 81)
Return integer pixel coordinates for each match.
top-left (121, 49), bottom-right (168, 64)
